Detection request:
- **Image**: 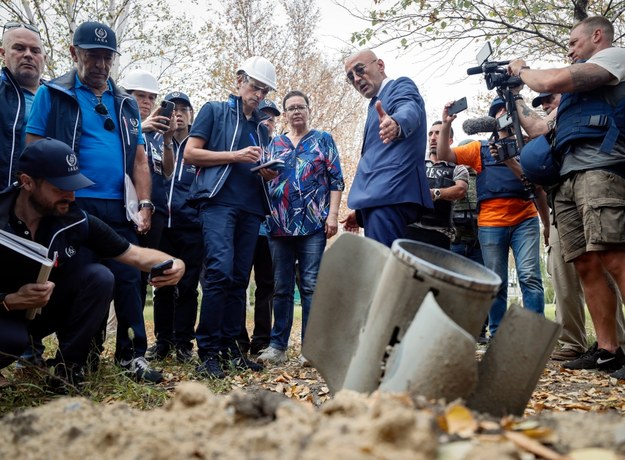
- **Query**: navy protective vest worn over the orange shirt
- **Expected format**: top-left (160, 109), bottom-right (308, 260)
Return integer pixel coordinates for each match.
top-left (475, 141), bottom-right (532, 209)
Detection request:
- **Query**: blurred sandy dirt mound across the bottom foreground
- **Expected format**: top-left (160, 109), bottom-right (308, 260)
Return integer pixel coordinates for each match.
top-left (0, 382), bottom-right (625, 460)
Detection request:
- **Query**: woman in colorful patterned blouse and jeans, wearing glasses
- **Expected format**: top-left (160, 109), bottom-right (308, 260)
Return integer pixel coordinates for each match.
top-left (258, 91), bottom-right (344, 364)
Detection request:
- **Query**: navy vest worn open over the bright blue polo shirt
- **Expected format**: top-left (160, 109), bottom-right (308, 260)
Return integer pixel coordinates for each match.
top-left (39, 69), bottom-right (141, 192)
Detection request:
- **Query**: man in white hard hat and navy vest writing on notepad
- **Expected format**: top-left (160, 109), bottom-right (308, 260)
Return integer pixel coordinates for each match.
top-left (184, 56), bottom-right (277, 378)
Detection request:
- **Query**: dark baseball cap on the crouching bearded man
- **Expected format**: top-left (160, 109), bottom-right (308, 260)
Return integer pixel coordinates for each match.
top-left (18, 137), bottom-right (94, 192)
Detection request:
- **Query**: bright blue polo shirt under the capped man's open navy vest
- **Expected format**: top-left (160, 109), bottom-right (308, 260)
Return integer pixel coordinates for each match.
top-left (26, 77), bottom-right (144, 200)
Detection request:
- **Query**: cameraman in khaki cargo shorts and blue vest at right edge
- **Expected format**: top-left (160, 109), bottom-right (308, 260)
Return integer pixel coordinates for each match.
top-left (509, 16), bottom-right (625, 379)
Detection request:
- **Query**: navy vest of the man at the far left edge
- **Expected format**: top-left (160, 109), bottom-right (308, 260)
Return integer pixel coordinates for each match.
top-left (0, 67), bottom-right (26, 189)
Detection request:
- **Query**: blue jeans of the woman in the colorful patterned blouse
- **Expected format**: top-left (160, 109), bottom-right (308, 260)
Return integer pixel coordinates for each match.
top-left (269, 231), bottom-right (326, 351)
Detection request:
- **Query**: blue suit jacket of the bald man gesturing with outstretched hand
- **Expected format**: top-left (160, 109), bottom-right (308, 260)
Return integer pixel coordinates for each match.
top-left (347, 77), bottom-right (433, 209)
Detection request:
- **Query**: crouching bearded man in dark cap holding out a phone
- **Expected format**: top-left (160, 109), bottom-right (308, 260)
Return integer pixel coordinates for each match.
top-left (0, 138), bottom-right (185, 385)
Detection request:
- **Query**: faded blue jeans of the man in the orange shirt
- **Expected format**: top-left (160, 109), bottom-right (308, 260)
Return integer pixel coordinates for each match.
top-left (478, 217), bottom-right (545, 336)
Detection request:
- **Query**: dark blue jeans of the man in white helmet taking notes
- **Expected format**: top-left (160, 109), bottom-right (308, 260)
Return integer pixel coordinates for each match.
top-left (195, 204), bottom-right (262, 360)
